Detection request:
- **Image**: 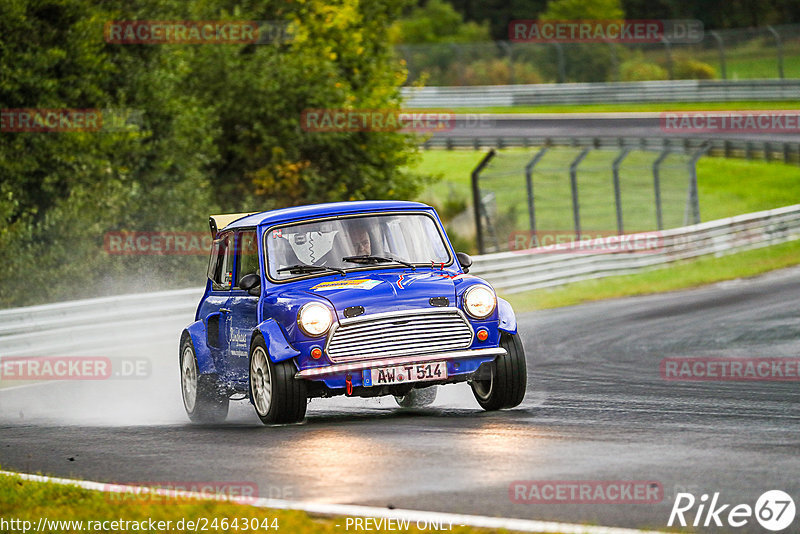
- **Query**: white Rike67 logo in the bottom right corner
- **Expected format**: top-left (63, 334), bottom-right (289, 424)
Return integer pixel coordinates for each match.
top-left (667, 490), bottom-right (796, 532)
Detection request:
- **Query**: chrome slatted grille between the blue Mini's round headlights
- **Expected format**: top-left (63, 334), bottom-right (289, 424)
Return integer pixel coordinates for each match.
top-left (325, 308), bottom-right (473, 363)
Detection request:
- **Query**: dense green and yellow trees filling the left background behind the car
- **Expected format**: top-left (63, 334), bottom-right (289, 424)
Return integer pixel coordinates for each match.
top-left (0, 0), bottom-right (423, 306)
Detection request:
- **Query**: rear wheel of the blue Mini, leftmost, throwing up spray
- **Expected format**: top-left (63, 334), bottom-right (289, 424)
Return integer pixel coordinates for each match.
top-left (179, 335), bottom-right (229, 423)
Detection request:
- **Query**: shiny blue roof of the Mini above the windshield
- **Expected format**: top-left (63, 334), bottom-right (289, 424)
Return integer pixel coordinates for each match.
top-left (225, 200), bottom-right (432, 229)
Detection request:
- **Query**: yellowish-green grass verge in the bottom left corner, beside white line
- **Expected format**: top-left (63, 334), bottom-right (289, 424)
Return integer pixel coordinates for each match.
top-left (0, 475), bottom-right (500, 534)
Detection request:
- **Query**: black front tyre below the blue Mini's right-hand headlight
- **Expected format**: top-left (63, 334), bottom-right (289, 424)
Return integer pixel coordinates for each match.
top-left (470, 334), bottom-right (528, 411)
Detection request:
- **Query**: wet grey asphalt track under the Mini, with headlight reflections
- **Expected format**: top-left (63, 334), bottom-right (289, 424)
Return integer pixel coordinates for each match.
top-left (0, 269), bottom-right (800, 532)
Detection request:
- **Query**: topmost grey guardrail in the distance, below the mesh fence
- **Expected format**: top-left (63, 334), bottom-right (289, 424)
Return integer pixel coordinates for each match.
top-left (402, 79), bottom-right (800, 109)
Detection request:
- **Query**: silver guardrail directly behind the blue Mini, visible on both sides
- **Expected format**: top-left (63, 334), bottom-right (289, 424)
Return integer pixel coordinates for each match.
top-left (0, 204), bottom-right (800, 357)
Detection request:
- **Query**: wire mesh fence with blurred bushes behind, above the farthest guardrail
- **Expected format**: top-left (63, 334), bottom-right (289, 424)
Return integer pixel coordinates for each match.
top-left (395, 21), bottom-right (800, 86)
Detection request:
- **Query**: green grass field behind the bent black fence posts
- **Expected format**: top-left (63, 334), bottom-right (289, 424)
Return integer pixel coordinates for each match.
top-left (418, 148), bottom-right (800, 230)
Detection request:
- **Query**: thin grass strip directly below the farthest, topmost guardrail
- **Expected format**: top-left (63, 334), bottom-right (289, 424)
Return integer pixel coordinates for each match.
top-left (446, 100), bottom-right (800, 113)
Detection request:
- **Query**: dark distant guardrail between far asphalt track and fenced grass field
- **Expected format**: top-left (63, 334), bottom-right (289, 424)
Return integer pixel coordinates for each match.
top-left (421, 135), bottom-right (800, 164)
